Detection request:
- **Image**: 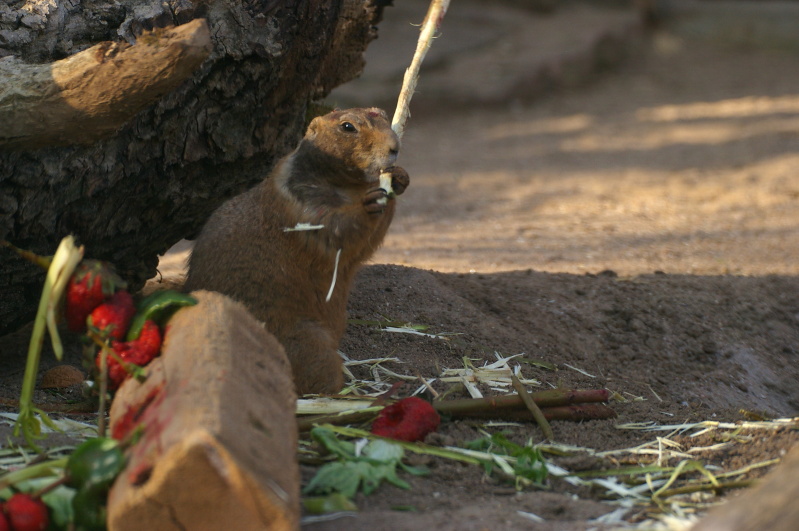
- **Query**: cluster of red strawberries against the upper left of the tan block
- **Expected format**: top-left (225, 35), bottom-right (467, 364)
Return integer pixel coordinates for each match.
top-left (65, 260), bottom-right (161, 389)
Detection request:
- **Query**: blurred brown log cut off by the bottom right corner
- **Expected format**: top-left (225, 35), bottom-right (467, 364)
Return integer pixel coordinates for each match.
top-left (691, 446), bottom-right (799, 531)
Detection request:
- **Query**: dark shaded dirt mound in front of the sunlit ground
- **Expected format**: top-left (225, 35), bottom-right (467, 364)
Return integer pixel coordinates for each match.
top-left (304, 265), bottom-right (799, 530)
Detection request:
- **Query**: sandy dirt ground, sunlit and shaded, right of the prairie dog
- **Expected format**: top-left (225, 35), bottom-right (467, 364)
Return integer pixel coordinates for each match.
top-left (0, 2), bottom-right (799, 530)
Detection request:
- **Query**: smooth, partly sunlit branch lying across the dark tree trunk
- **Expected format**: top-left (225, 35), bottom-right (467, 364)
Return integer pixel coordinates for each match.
top-left (0, 19), bottom-right (211, 149)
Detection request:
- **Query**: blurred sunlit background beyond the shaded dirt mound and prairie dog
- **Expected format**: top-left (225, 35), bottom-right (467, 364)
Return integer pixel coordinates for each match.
top-left (161, 0), bottom-right (799, 275)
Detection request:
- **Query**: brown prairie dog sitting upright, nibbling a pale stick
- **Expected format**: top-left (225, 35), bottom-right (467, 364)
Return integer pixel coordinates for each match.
top-left (185, 109), bottom-right (408, 394)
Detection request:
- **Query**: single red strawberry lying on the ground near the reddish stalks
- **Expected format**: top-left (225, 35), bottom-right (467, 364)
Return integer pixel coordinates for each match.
top-left (372, 396), bottom-right (441, 442)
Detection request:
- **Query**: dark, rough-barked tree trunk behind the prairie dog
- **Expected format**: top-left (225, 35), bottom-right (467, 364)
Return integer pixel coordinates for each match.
top-left (0, 0), bottom-right (385, 334)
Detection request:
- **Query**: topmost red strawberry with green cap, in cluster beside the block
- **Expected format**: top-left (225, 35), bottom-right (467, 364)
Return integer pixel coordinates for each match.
top-left (65, 260), bottom-right (125, 332)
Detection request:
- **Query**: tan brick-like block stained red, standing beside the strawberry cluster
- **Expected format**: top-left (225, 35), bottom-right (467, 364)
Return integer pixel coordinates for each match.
top-left (108, 291), bottom-right (299, 531)
